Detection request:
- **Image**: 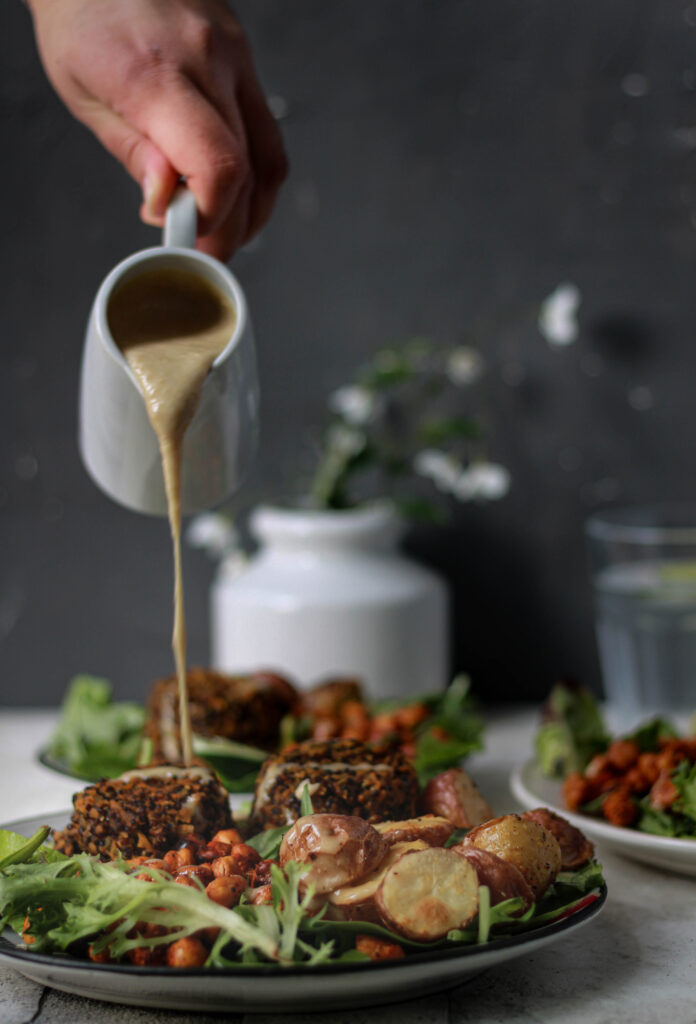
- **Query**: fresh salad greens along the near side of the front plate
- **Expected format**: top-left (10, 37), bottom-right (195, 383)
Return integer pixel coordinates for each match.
top-left (0, 829), bottom-right (603, 968)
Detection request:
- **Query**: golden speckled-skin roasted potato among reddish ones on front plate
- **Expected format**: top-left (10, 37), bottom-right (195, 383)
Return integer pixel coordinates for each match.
top-left (460, 814), bottom-right (561, 900)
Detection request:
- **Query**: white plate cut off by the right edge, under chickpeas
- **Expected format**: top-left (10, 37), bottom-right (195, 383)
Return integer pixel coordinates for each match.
top-left (510, 760), bottom-right (696, 876)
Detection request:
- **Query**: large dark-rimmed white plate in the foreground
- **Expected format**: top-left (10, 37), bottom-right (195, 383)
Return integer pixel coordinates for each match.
top-left (0, 812), bottom-right (606, 1013)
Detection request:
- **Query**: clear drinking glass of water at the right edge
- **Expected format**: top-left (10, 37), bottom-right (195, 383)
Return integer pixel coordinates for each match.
top-left (585, 505), bottom-right (696, 714)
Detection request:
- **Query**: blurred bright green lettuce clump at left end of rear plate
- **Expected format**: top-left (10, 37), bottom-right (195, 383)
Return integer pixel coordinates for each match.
top-left (47, 675), bottom-right (145, 781)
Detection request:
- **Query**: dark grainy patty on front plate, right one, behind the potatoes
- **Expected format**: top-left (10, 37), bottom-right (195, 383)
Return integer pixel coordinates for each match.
top-left (250, 739), bottom-right (419, 834)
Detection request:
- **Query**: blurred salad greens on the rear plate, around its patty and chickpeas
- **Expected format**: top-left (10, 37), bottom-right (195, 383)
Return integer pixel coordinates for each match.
top-left (45, 675), bottom-right (483, 793)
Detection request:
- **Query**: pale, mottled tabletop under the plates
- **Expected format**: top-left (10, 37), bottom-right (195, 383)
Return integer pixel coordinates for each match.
top-left (0, 711), bottom-right (696, 1024)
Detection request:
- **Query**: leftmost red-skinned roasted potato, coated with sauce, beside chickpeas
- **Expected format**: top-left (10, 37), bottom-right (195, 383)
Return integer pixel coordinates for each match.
top-left (279, 814), bottom-right (388, 895)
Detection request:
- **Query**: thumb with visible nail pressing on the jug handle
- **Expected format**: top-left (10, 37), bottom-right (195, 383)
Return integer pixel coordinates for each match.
top-left (79, 104), bottom-right (179, 225)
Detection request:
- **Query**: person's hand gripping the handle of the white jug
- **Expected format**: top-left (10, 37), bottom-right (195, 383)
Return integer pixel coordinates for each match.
top-left (29, 0), bottom-right (288, 259)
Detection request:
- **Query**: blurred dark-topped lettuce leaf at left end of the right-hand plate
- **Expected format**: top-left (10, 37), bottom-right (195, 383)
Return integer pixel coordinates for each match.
top-left (534, 683), bottom-right (609, 778)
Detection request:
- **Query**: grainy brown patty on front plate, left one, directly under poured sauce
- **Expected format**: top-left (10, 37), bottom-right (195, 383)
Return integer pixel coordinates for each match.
top-left (53, 767), bottom-right (233, 860)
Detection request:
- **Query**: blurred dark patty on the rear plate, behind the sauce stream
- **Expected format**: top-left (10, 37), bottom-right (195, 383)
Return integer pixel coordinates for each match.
top-left (145, 668), bottom-right (298, 763)
